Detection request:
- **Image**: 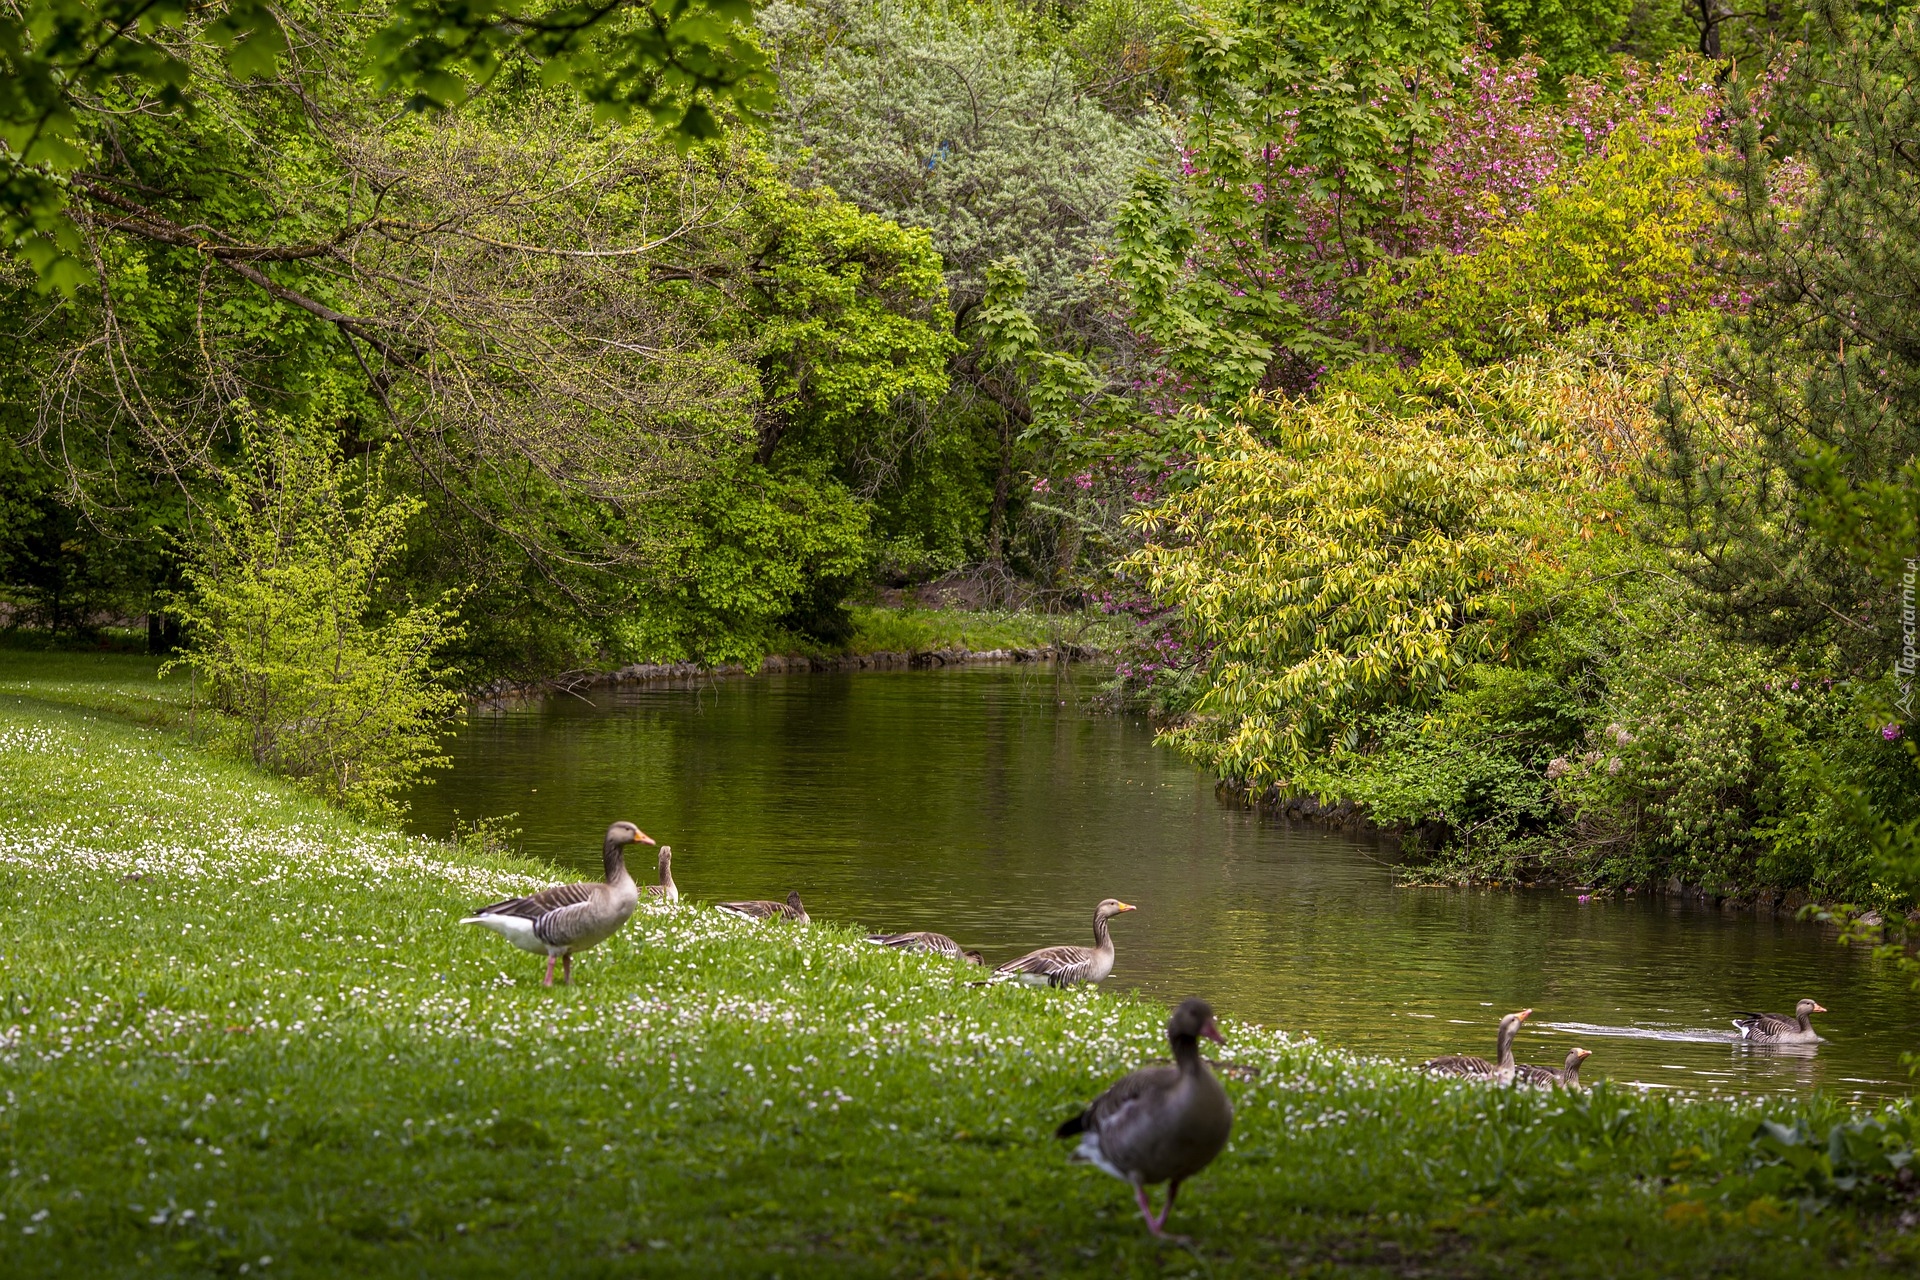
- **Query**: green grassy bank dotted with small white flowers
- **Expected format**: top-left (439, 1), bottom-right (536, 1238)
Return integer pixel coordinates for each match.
top-left (0, 654), bottom-right (1920, 1276)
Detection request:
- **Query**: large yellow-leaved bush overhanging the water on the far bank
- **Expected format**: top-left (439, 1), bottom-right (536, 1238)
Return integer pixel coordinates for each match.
top-left (1127, 363), bottom-right (1647, 783)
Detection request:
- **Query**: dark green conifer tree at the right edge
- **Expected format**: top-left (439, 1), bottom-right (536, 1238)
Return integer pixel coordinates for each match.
top-left (1655, 4), bottom-right (1920, 676)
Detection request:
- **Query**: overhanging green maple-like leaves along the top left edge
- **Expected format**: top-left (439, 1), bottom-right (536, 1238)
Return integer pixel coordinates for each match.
top-left (0, 0), bottom-right (766, 290)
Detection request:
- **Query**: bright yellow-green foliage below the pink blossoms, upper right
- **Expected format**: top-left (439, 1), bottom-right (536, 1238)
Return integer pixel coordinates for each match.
top-left (1369, 63), bottom-right (1720, 361)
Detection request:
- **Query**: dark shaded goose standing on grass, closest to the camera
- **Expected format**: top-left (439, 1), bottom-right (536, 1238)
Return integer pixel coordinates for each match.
top-left (1054, 1000), bottom-right (1233, 1236)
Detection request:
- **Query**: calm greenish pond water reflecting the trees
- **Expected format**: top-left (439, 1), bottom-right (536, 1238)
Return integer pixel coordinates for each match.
top-left (413, 668), bottom-right (1920, 1096)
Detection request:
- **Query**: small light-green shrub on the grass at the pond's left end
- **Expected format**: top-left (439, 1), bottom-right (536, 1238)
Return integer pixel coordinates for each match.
top-left (167, 403), bottom-right (459, 814)
